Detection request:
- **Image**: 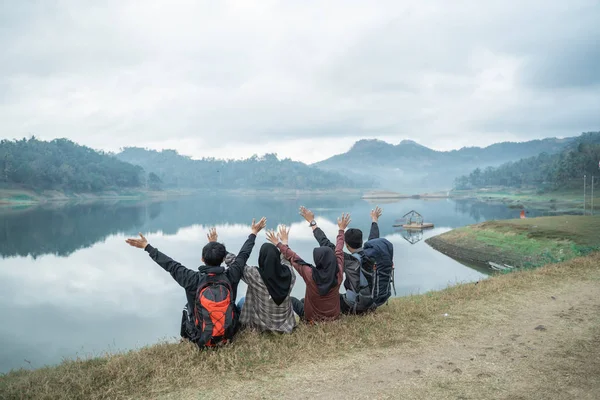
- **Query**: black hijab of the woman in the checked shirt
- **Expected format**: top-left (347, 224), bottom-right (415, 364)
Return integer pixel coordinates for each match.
top-left (258, 243), bottom-right (292, 305)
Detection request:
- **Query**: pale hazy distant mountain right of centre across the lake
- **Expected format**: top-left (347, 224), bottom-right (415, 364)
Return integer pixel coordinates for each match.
top-left (313, 138), bottom-right (574, 193)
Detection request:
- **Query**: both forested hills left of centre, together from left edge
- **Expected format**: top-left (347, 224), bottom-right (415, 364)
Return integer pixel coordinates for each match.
top-left (0, 137), bottom-right (356, 193)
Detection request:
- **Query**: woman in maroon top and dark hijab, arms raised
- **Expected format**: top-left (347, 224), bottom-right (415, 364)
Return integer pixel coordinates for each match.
top-left (267, 214), bottom-right (350, 322)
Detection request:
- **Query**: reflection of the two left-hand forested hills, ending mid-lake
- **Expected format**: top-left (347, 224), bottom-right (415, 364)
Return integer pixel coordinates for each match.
top-left (0, 195), bottom-right (355, 257)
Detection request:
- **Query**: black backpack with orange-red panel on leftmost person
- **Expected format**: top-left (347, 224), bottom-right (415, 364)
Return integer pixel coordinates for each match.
top-left (192, 274), bottom-right (239, 348)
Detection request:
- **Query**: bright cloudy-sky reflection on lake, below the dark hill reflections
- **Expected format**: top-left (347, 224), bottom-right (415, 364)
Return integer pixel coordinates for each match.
top-left (0, 201), bottom-right (496, 372)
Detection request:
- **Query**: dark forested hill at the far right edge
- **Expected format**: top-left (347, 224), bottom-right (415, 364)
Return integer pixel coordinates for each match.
top-left (455, 132), bottom-right (600, 189)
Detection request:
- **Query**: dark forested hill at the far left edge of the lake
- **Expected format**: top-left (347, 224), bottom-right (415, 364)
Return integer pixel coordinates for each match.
top-left (0, 137), bottom-right (145, 192)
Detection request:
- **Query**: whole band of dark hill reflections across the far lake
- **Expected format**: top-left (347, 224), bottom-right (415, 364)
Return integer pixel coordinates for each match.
top-left (0, 194), bottom-right (535, 257)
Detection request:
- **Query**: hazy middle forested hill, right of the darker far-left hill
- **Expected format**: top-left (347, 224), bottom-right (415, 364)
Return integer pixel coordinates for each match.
top-left (116, 147), bottom-right (356, 189)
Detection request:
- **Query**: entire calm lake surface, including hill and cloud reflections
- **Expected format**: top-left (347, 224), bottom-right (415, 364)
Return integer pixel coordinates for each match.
top-left (0, 195), bottom-right (535, 373)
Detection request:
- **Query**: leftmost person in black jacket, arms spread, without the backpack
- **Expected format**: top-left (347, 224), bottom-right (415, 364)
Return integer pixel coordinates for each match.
top-left (126, 217), bottom-right (267, 339)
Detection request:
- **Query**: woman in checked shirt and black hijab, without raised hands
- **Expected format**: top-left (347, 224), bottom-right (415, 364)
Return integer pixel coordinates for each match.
top-left (226, 238), bottom-right (296, 333)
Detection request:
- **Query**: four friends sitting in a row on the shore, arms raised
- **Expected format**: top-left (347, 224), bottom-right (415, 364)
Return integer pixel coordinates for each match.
top-left (126, 207), bottom-right (393, 348)
